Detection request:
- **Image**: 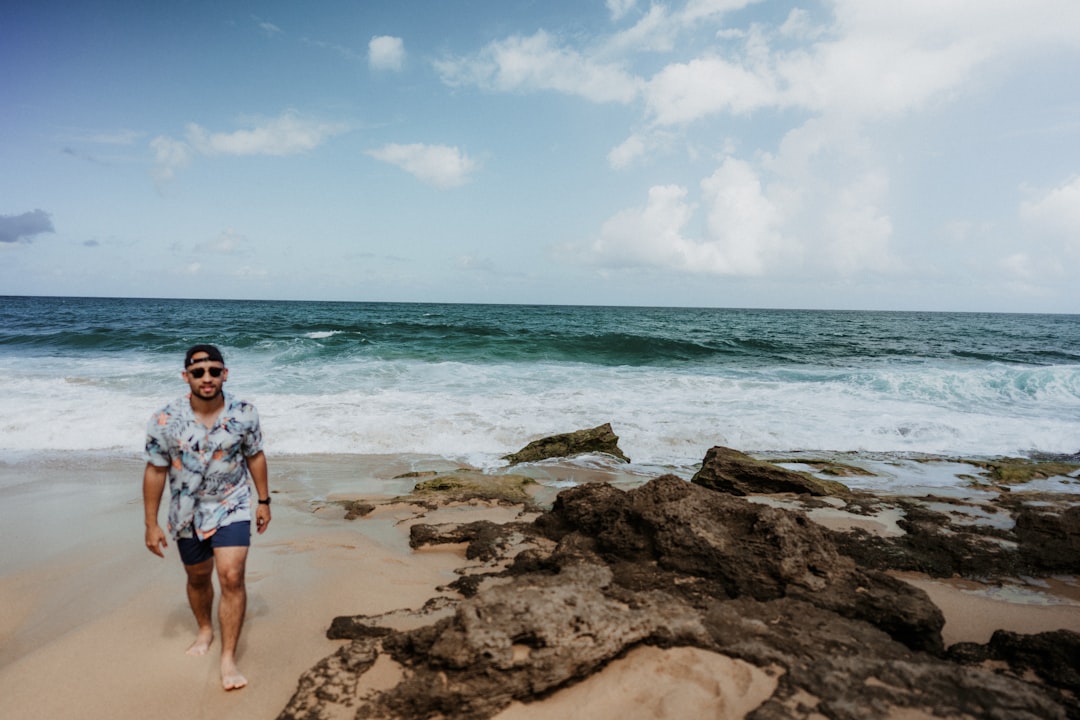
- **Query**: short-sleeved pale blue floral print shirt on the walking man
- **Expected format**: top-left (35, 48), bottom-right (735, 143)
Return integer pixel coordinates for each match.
top-left (146, 394), bottom-right (262, 540)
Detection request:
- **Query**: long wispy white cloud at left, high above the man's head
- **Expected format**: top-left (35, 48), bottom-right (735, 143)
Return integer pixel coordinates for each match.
top-left (150, 110), bottom-right (348, 182)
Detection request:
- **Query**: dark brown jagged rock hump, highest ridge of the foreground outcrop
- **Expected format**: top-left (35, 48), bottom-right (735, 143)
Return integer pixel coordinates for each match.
top-left (536, 475), bottom-right (944, 652)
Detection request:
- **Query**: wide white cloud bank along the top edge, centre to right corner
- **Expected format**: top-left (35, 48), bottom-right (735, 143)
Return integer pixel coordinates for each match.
top-left (435, 0), bottom-right (1080, 131)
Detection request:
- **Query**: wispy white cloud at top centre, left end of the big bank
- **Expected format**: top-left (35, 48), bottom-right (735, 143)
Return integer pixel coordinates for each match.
top-left (435, 30), bottom-right (639, 103)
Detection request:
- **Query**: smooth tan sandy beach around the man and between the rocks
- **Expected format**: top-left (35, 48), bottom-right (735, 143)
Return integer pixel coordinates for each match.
top-left (0, 454), bottom-right (1080, 720)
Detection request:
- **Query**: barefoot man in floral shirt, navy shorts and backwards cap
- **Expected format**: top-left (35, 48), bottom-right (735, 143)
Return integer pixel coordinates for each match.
top-left (143, 344), bottom-right (270, 690)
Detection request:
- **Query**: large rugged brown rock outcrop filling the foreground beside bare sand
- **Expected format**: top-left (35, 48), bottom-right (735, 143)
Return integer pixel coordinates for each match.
top-left (281, 476), bottom-right (1080, 720)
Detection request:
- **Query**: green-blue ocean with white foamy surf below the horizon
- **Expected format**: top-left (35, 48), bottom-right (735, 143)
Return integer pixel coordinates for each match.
top-left (0, 297), bottom-right (1080, 468)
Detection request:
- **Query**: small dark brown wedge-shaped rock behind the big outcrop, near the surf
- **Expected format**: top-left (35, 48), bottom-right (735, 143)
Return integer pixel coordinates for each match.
top-left (691, 446), bottom-right (849, 495)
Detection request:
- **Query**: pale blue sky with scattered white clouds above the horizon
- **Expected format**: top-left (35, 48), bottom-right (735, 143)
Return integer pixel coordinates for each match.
top-left (0, 0), bottom-right (1080, 313)
